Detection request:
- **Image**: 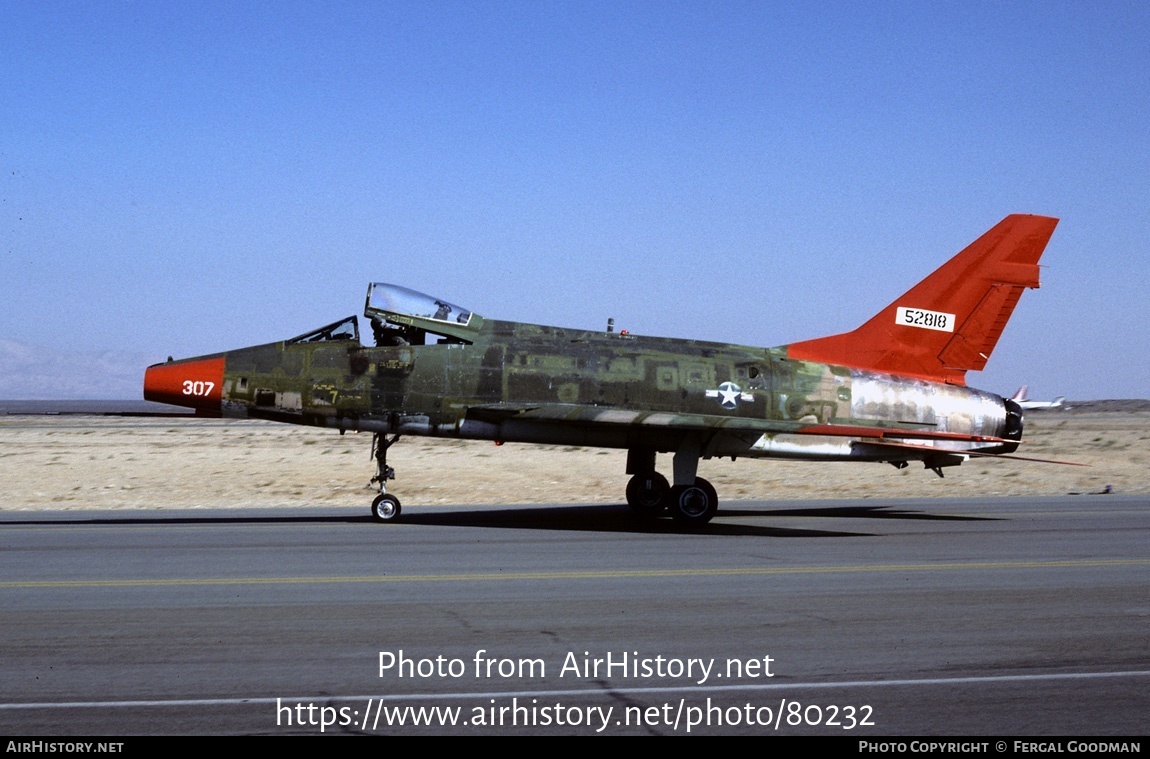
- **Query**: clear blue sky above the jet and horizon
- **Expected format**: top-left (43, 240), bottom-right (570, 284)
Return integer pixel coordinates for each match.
top-left (0, 0), bottom-right (1150, 399)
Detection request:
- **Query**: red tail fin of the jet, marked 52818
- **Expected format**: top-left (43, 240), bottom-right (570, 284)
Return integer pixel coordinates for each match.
top-left (787, 214), bottom-right (1058, 385)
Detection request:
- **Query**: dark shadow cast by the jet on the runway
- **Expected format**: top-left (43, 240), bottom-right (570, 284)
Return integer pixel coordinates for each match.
top-left (0, 504), bottom-right (994, 538)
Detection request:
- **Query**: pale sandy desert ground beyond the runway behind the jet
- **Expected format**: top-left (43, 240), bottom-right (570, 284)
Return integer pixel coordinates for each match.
top-left (0, 401), bottom-right (1150, 511)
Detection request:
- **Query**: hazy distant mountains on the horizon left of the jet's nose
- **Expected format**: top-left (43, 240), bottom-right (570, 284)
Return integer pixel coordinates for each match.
top-left (0, 338), bottom-right (163, 400)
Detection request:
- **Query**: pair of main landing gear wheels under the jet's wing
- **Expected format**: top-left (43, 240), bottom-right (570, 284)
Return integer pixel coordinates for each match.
top-left (627, 443), bottom-right (719, 526)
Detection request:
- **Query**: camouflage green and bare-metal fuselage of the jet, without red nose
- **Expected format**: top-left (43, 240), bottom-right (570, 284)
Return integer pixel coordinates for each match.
top-left (193, 316), bottom-right (1009, 460)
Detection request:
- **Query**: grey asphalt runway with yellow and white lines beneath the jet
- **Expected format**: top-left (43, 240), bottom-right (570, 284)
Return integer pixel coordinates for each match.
top-left (0, 496), bottom-right (1150, 738)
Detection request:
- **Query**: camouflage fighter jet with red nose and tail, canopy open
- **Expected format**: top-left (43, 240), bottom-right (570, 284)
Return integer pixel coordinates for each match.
top-left (144, 215), bottom-right (1058, 526)
